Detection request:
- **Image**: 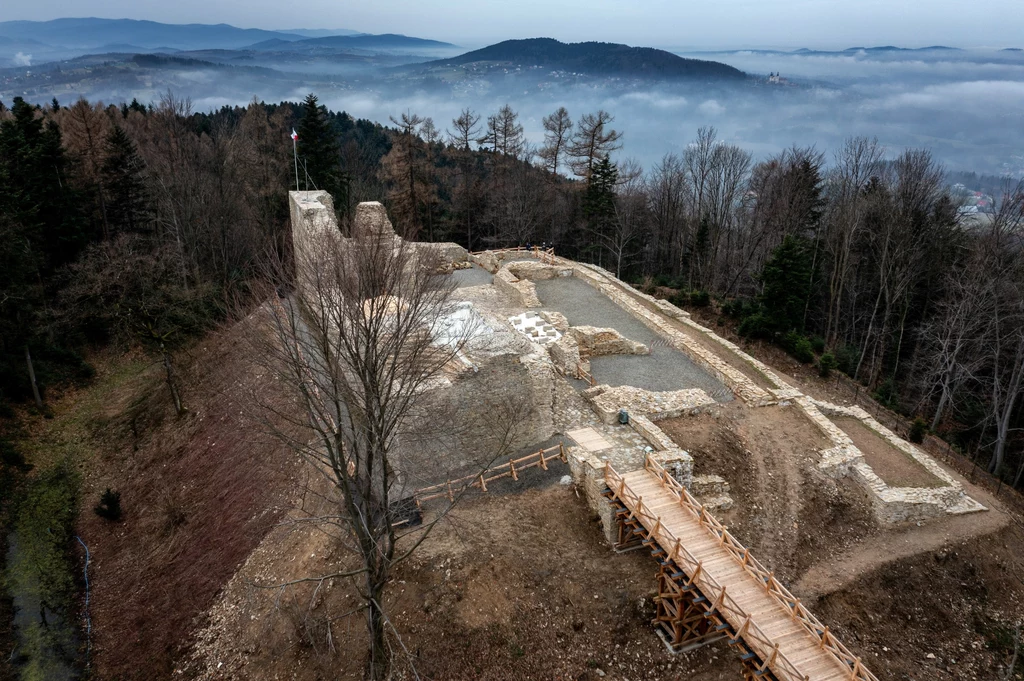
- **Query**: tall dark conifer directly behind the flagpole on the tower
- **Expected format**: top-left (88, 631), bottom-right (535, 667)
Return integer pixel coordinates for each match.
top-left (298, 93), bottom-right (348, 211)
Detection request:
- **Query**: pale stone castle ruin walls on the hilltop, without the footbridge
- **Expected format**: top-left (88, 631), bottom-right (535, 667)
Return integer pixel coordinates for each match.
top-left (290, 191), bottom-right (985, 537)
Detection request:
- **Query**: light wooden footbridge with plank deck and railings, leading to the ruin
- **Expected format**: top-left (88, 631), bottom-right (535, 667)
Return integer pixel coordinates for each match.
top-left (605, 457), bottom-right (878, 681)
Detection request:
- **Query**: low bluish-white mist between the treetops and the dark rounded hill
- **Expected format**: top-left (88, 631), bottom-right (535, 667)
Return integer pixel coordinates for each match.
top-left (8, 49), bottom-right (1024, 175)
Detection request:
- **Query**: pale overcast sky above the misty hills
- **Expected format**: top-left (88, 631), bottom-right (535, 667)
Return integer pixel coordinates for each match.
top-left (0, 0), bottom-right (1024, 48)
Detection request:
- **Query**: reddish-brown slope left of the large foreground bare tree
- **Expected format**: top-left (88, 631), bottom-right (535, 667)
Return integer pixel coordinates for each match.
top-left (70, 319), bottom-right (297, 679)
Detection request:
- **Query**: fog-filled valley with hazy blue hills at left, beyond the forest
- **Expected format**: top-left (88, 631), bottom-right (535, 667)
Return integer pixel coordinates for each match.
top-left (0, 19), bottom-right (1024, 175)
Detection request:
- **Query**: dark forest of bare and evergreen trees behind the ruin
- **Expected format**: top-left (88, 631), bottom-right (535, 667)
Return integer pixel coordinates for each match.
top-left (0, 95), bottom-right (1024, 485)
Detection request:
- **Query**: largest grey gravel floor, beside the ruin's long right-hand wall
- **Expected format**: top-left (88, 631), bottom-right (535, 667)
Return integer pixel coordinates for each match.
top-left (537, 276), bottom-right (733, 401)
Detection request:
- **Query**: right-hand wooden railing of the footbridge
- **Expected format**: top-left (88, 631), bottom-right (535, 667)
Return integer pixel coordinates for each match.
top-left (609, 456), bottom-right (878, 681)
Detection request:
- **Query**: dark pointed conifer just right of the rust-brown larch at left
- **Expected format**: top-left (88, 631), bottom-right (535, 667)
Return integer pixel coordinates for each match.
top-left (101, 125), bottom-right (152, 235)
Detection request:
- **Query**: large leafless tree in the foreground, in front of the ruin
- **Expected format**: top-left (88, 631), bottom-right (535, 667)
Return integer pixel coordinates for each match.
top-left (257, 204), bottom-right (522, 681)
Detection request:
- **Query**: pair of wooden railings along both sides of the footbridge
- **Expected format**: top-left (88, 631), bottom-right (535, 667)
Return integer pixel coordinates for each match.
top-left (605, 455), bottom-right (878, 681)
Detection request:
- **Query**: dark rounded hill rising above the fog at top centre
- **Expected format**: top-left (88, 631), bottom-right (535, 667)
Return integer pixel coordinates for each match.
top-left (423, 38), bottom-right (746, 80)
